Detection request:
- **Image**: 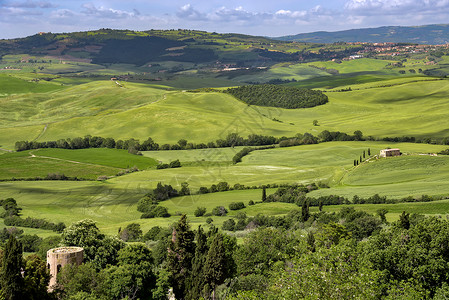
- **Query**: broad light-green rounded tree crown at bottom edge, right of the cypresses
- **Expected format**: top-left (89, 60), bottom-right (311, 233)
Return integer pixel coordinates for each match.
top-left (265, 244), bottom-right (380, 299)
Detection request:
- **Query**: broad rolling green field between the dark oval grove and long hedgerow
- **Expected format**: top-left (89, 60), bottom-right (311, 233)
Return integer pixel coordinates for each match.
top-left (0, 77), bottom-right (449, 149)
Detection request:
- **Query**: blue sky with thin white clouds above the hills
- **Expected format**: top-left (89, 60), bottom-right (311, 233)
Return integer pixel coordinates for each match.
top-left (0, 0), bottom-right (449, 39)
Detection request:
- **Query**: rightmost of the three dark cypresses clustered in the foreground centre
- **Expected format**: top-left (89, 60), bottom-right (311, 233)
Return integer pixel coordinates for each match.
top-left (204, 234), bottom-right (227, 299)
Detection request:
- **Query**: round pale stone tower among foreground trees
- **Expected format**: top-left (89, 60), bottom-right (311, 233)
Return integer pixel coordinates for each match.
top-left (47, 247), bottom-right (84, 289)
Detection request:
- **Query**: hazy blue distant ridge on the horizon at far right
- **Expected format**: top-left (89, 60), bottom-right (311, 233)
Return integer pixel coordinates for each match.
top-left (275, 24), bottom-right (449, 45)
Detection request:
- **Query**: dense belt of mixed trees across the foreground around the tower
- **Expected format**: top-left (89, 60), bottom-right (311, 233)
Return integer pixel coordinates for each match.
top-left (0, 211), bottom-right (449, 300)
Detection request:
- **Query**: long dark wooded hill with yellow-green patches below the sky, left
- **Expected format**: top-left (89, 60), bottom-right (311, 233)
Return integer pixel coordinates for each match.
top-left (0, 29), bottom-right (364, 68)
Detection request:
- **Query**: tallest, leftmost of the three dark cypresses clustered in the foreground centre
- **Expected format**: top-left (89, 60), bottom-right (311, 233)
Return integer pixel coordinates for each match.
top-left (167, 215), bottom-right (195, 299)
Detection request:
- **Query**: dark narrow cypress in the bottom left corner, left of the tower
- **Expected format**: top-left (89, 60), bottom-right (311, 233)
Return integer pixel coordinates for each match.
top-left (0, 235), bottom-right (25, 300)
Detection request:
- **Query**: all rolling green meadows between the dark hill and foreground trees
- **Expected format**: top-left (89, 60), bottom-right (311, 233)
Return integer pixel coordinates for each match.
top-left (0, 51), bottom-right (449, 236)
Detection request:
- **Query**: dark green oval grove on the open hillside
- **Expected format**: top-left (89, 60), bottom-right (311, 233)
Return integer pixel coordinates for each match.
top-left (225, 84), bottom-right (328, 109)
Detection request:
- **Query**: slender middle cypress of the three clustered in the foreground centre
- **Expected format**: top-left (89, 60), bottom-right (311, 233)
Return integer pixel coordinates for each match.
top-left (187, 226), bottom-right (208, 299)
